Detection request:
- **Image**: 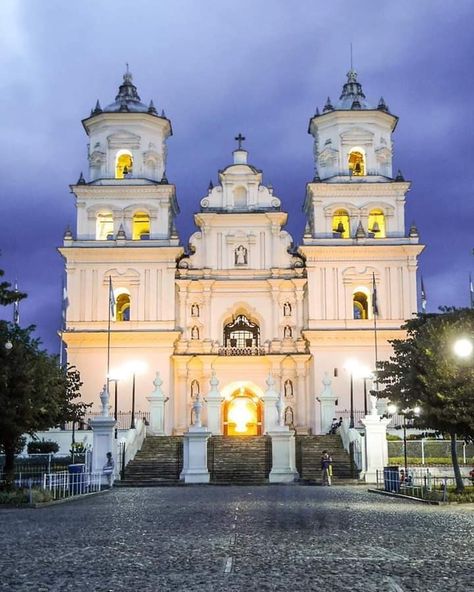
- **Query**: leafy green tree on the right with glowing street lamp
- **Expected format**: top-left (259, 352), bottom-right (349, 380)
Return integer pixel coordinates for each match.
top-left (373, 308), bottom-right (474, 492)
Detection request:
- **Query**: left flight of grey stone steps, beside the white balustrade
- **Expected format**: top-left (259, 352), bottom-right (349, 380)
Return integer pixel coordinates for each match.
top-left (115, 436), bottom-right (183, 487)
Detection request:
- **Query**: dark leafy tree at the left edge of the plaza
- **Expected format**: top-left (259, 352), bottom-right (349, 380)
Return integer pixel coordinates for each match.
top-left (0, 321), bottom-right (87, 486)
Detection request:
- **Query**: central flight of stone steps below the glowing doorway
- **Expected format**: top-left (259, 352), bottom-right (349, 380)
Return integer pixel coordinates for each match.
top-left (207, 436), bottom-right (272, 485)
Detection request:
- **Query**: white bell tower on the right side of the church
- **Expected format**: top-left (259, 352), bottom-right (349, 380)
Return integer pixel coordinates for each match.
top-left (300, 68), bottom-right (423, 416)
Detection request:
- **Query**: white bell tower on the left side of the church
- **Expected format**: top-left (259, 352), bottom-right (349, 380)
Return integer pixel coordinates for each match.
top-left (60, 66), bottom-right (183, 408)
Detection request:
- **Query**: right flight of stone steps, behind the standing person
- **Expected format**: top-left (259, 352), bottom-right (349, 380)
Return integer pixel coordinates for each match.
top-left (296, 435), bottom-right (359, 485)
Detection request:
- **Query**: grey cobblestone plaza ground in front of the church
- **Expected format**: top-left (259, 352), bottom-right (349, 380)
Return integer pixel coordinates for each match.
top-left (0, 486), bottom-right (474, 592)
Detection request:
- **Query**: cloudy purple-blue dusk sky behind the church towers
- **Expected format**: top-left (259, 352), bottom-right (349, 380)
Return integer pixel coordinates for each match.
top-left (0, 0), bottom-right (474, 352)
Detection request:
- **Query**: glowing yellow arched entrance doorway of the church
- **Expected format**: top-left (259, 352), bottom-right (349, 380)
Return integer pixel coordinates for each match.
top-left (224, 388), bottom-right (262, 436)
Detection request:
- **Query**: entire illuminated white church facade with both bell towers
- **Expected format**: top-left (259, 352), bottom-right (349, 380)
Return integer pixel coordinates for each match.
top-left (60, 70), bottom-right (423, 435)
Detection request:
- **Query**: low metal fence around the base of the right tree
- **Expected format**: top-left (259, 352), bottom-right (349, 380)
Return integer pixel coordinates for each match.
top-left (376, 467), bottom-right (472, 501)
